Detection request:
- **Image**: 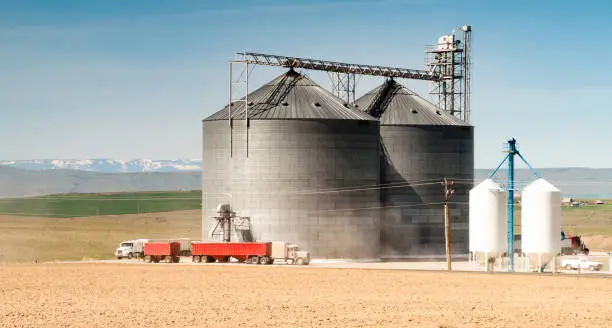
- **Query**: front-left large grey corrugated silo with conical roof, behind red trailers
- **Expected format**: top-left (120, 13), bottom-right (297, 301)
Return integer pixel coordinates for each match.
top-left (202, 70), bottom-right (380, 258)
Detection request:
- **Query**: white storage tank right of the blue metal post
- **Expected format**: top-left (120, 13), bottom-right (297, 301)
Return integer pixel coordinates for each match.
top-left (521, 178), bottom-right (561, 266)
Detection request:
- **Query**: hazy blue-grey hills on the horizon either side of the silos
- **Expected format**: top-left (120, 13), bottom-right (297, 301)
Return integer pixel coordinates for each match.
top-left (0, 165), bottom-right (612, 198)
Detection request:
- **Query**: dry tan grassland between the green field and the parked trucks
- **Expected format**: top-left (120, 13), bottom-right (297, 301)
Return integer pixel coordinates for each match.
top-left (0, 210), bottom-right (201, 263)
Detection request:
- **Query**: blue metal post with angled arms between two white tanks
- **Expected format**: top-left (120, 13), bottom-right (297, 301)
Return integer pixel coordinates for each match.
top-left (489, 138), bottom-right (541, 271)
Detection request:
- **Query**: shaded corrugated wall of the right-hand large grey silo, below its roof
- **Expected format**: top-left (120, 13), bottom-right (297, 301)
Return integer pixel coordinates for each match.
top-left (380, 125), bottom-right (474, 258)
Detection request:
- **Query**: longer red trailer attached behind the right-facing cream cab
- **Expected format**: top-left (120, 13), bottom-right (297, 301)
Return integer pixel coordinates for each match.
top-left (191, 242), bottom-right (274, 264)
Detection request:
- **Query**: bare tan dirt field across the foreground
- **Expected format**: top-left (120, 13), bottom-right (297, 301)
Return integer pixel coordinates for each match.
top-left (0, 264), bottom-right (612, 327)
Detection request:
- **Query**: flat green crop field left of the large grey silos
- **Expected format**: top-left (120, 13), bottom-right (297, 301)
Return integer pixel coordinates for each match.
top-left (0, 191), bottom-right (202, 218)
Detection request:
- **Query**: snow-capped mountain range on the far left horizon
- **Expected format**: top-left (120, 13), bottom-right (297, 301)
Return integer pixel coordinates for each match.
top-left (0, 159), bottom-right (202, 173)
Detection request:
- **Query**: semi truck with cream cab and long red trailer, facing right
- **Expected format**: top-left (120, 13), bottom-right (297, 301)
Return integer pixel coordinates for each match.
top-left (191, 242), bottom-right (310, 265)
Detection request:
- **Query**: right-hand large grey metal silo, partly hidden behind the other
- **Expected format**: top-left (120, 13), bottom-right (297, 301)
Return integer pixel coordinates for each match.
top-left (355, 79), bottom-right (474, 258)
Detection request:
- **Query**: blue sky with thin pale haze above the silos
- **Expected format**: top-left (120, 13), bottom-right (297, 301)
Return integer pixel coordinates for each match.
top-left (0, 0), bottom-right (612, 168)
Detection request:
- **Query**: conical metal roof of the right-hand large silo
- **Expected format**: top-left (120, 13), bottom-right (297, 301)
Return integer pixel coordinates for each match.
top-left (355, 79), bottom-right (470, 126)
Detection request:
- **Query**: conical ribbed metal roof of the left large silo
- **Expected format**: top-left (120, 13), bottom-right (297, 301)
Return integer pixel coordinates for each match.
top-left (204, 69), bottom-right (376, 121)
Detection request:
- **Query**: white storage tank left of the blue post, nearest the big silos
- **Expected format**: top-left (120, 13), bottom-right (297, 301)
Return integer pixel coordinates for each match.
top-left (469, 179), bottom-right (508, 259)
